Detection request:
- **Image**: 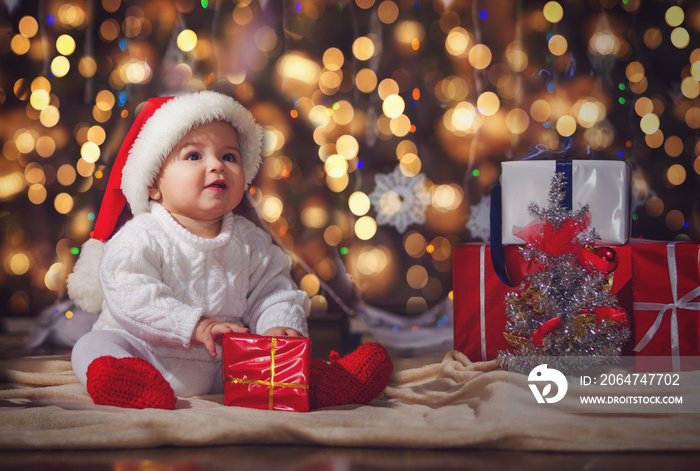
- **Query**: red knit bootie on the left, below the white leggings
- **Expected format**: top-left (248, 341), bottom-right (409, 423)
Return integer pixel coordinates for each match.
top-left (87, 356), bottom-right (176, 410)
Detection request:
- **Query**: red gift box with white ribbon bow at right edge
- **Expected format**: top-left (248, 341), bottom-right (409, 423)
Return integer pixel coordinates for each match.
top-left (632, 242), bottom-right (700, 371)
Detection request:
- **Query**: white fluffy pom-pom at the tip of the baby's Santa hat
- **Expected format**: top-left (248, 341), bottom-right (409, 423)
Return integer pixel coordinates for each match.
top-left (67, 239), bottom-right (104, 314)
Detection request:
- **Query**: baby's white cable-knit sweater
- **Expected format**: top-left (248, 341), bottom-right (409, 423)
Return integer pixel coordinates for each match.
top-left (93, 202), bottom-right (309, 361)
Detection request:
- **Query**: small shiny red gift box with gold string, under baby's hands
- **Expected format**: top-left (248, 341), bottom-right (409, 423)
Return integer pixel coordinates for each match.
top-left (222, 334), bottom-right (311, 412)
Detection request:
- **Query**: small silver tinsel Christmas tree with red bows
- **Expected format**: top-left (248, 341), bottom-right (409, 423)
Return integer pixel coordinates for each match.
top-left (499, 172), bottom-right (630, 371)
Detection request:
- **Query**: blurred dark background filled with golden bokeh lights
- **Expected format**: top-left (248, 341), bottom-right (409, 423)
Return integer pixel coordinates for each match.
top-left (0, 0), bottom-right (700, 349)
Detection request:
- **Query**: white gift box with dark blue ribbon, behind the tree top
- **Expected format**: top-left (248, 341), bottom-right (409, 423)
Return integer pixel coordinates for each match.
top-left (501, 160), bottom-right (630, 245)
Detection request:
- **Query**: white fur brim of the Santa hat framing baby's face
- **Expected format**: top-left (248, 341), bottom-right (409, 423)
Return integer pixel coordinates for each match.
top-left (121, 91), bottom-right (262, 215)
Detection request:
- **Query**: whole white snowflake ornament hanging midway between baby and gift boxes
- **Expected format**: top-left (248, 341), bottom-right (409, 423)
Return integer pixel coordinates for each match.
top-left (368, 165), bottom-right (431, 234)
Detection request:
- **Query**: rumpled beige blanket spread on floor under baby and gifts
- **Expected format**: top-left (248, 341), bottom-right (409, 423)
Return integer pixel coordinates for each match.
top-left (0, 351), bottom-right (700, 451)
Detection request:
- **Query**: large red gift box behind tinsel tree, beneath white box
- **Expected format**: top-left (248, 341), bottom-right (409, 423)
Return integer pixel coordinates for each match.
top-left (452, 240), bottom-right (644, 361)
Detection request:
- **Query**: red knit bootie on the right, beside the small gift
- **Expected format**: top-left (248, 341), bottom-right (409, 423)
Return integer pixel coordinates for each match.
top-left (309, 343), bottom-right (394, 409)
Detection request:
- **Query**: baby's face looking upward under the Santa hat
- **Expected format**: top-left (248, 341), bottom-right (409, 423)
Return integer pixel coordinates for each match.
top-left (148, 121), bottom-right (245, 231)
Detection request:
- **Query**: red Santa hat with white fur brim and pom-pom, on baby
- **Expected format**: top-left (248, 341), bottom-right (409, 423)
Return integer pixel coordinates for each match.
top-left (68, 91), bottom-right (262, 313)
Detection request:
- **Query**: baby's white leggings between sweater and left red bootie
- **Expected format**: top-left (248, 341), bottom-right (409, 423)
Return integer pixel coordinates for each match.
top-left (71, 330), bottom-right (224, 397)
